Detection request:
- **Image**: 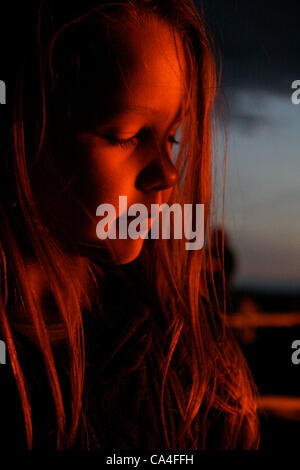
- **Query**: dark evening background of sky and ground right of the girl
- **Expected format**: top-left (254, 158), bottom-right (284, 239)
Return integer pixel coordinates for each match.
top-left (197, 0), bottom-right (300, 449)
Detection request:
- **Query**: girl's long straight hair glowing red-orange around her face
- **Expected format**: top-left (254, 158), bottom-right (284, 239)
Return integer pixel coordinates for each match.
top-left (0, 0), bottom-right (258, 449)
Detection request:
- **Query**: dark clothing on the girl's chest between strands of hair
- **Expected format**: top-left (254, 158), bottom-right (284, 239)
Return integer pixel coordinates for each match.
top-left (0, 266), bottom-right (230, 450)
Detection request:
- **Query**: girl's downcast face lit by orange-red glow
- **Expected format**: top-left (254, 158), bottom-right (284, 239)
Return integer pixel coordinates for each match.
top-left (49, 18), bottom-right (185, 264)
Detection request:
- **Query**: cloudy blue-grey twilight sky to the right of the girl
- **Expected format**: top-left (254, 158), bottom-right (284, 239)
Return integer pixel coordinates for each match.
top-left (200, 0), bottom-right (300, 289)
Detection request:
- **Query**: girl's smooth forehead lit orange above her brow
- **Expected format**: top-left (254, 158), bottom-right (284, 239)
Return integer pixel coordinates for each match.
top-left (101, 18), bottom-right (186, 119)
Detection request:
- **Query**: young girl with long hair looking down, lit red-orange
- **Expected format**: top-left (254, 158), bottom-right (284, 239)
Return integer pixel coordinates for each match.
top-left (0, 0), bottom-right (258, 449)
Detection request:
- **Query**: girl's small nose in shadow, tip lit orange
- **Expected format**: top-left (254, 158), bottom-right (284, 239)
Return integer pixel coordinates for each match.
top-left (136, 157), bottom-right (177, 192)
